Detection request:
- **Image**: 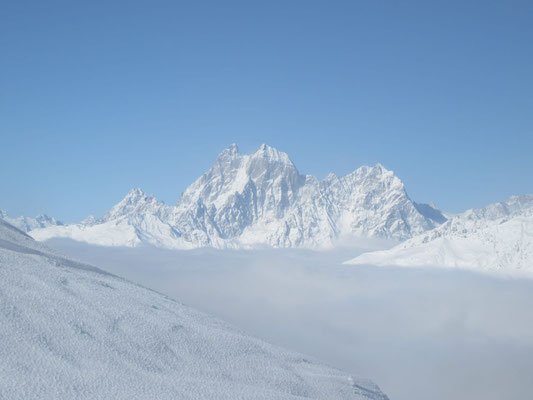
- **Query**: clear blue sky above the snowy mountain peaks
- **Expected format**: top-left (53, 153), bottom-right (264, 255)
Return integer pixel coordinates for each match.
top-left (0, 0), bottom-right (533, 221)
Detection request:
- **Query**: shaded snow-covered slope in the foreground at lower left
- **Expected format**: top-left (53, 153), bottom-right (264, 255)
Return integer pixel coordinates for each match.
top-left (0, 221), bottom-right (386, 399)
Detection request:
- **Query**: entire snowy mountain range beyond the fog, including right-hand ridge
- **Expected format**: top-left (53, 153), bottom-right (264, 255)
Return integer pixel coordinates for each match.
top-left (0, 145), bottom-right (533, 273)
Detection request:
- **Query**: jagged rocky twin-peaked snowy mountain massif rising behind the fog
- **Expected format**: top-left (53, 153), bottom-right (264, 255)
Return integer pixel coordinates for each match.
top-left (31, 145), bottom-right (446, 249)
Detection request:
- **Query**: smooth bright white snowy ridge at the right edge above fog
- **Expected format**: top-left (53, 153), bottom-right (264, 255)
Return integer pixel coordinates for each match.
top-left (347, 195), bottom-right (533, 276)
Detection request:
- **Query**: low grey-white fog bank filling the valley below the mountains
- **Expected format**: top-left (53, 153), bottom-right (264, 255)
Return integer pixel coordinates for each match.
top-left (48, 240), bottom-right (533, 400)
